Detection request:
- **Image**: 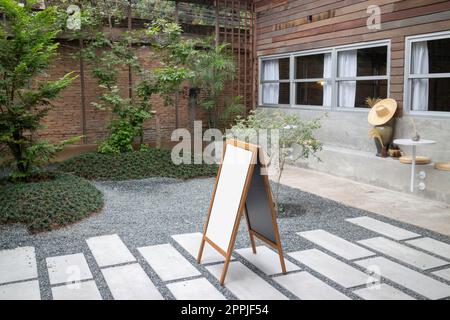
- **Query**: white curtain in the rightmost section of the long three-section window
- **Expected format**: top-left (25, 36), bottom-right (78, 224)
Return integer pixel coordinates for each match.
top-left (338, 50), bottom-right (357, 108)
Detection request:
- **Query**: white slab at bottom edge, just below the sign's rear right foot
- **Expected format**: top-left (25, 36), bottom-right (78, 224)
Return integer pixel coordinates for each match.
top-left (273, 272), bottom-right (350, 300)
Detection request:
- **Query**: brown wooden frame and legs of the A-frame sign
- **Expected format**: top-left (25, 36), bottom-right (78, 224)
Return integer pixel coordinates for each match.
top-left (197, 140), bottom-right (286, 286)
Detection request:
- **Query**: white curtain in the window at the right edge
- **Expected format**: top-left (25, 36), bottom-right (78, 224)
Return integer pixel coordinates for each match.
top-left (411, 41), bottom-right (429, 111)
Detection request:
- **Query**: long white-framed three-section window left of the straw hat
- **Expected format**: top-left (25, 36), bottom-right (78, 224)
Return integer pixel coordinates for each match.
top-left (259, 40), bottom-right (390, 110)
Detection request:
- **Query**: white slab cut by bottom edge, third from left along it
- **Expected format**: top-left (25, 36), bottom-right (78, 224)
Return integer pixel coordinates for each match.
top-left (102, 263), bottom-right (163, 300)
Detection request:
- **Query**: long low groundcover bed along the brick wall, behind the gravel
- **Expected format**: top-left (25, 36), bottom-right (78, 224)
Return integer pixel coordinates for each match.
top-left (57, 149), bottom-right (217, 181)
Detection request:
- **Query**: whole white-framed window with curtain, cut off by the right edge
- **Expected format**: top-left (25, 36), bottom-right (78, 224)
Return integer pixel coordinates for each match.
top-left (404, 31), bottom-right (450, 116)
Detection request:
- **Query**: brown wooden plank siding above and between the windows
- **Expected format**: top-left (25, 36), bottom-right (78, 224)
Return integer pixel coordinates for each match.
top-left (255, 0), bottom-right (450, 109)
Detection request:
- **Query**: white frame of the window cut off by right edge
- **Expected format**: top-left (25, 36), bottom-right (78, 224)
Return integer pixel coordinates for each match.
top-left (403, 31), bottom-right (450, 118)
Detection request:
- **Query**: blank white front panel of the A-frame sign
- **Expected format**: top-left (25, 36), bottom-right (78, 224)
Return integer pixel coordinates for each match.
top-left (206, 144), bottom-right (253, 252)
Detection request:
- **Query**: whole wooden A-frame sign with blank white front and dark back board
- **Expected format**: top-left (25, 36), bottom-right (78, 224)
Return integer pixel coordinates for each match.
top-left (197, 140), bottom-right (286, 285)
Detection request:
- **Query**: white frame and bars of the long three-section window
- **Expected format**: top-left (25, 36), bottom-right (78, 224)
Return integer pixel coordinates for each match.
top-left (258, 39), bottom-right (391, 113)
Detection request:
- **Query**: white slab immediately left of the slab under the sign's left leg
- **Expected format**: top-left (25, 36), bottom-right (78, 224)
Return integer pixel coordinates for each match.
top-left (138, 244), bottom-right (201, 281)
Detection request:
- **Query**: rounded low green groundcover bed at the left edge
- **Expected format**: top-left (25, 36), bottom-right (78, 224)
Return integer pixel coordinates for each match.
top-left (0, 173), bottom-right (103, 232)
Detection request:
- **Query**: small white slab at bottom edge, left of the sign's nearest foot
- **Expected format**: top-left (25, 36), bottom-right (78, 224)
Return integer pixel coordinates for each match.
top-left (167, 278), bottom-right (226, 300)
